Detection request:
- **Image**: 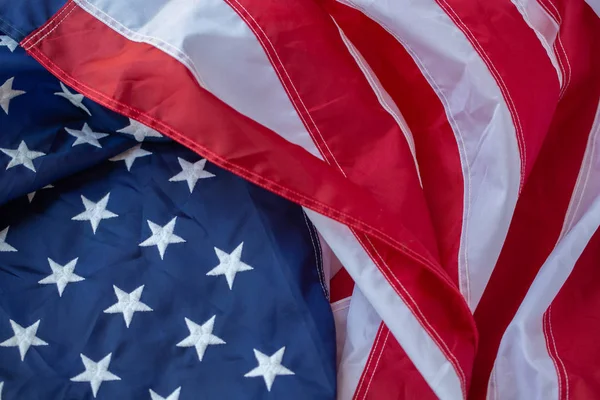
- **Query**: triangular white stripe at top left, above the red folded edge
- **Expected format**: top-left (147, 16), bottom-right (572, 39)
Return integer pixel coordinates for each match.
top-left (75, 0), bottom-right (322, 159)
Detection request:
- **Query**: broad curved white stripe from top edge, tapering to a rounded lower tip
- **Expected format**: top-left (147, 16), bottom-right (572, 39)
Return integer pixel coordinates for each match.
top-left (338, 0), bottom-right (521, 309)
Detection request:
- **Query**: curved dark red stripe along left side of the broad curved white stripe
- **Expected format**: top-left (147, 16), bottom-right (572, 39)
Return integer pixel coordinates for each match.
top-left (328, 1), bottom-right (464, 285)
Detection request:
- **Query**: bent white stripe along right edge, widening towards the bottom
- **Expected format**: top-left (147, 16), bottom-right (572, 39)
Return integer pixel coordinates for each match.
top-left (489, 102), bottom-right (600, 400)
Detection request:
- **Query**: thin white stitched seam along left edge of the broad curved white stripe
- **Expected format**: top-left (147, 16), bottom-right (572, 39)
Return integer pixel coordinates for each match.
top-left (337, 0), bottom-right (472, 304)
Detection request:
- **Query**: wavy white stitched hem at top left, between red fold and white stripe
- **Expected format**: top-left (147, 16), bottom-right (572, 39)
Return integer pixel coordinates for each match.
top-left (76, 0), bottom-right (208, 88)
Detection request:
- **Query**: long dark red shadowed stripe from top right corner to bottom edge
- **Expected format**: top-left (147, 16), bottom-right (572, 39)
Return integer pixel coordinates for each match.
top-left (471, 1), bottom-right (600, 399)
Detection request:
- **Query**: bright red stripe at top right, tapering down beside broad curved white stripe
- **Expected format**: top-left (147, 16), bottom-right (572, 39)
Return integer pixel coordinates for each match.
top-left (436, 0), bottom-right (560, 185)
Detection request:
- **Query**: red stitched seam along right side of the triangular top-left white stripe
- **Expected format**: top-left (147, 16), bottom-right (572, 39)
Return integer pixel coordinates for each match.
top-left (225, 0), bottom-right (346, 177)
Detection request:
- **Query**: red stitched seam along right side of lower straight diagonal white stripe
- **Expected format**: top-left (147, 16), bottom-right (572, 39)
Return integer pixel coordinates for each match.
top-left (350, 228), bottom-right (467, 399)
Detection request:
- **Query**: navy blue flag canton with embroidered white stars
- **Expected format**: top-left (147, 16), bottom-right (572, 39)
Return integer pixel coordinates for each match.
top-left (0, 36), bottom-right (336, 400)
